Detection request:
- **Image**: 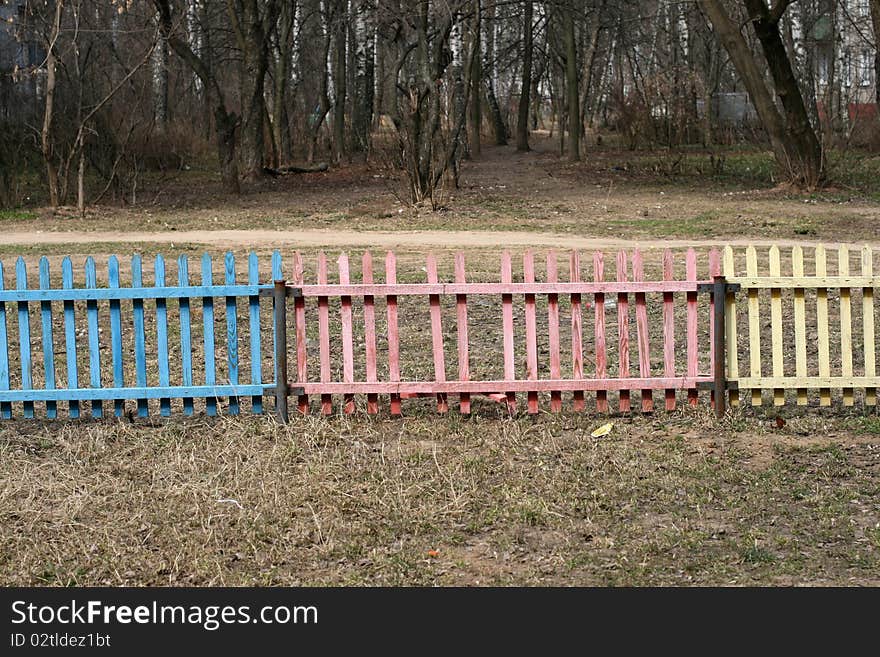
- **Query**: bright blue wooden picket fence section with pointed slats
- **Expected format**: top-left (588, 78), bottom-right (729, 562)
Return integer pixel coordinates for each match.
top-left (0, 251), bottom-right (283, 419)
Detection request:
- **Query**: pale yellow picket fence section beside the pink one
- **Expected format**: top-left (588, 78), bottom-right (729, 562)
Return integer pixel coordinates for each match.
top-left (722, 245), bottom-right (880, 406)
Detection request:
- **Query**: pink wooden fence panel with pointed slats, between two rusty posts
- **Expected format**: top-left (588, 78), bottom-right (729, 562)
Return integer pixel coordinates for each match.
top-left (277, 250), bottom-right (724, 417)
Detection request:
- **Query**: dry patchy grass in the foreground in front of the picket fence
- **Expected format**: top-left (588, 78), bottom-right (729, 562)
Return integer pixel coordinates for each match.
top-left (0, 413), bottom-right (880, 585)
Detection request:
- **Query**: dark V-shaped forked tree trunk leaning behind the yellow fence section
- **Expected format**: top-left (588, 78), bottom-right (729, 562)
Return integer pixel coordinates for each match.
top-left (699, 0), bottom-right (825, 188)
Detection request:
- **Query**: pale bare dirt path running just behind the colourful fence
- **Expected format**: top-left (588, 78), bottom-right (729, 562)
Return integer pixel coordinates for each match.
top-left (0, 230), bottom-right (880, 249)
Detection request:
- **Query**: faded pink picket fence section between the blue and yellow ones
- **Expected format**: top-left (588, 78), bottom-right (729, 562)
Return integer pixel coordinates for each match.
top-left (275, 250), bottom-right (728, 419)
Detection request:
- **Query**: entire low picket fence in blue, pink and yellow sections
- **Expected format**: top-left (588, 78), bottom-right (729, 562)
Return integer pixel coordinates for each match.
top-left (0, 247), bottom-right (880, 419)
